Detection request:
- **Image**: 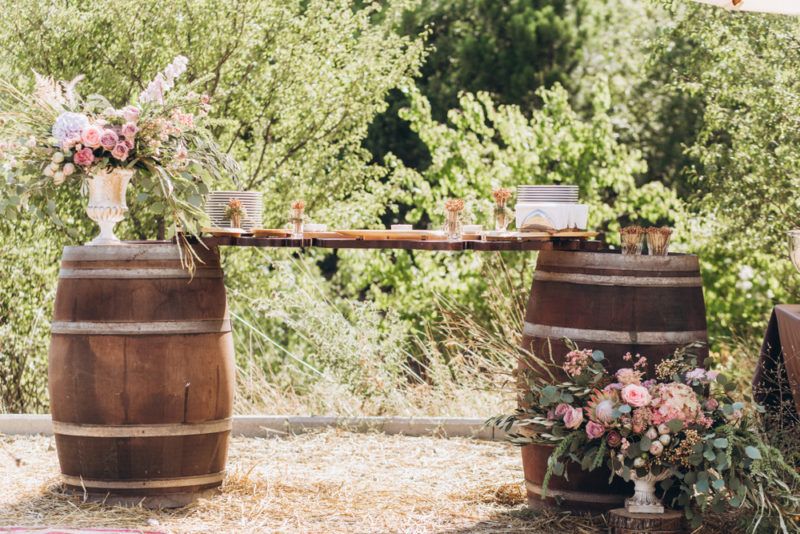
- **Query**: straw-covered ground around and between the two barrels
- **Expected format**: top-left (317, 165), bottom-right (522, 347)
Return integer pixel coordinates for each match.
top-left (0, 430), bottom-right (603, 534)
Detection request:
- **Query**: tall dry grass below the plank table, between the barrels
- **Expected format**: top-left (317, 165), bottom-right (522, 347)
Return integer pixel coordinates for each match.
top-left (230, 251), bottom-right (524, 417)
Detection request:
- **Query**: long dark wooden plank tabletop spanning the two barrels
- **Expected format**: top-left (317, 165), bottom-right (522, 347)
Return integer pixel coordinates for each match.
top-left (195, 237), bottom-right (606, 252)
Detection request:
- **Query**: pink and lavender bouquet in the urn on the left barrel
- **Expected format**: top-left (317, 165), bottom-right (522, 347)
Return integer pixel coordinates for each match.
top-left (0, 56), bottom-right (238, 264)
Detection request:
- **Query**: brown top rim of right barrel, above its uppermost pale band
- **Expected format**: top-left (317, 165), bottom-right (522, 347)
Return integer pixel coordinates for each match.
top-left (536, 250), bottom-right (700, 272)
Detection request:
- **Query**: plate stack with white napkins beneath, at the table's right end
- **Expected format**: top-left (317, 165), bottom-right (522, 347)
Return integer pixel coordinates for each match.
top-left (516, 185), bottom-right (589, 231)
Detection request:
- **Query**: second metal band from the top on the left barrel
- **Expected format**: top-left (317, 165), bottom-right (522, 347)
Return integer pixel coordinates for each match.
top-left (50, 319), bottom-right (231, 336)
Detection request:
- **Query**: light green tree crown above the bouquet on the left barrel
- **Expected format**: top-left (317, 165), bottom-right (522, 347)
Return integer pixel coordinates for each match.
top-left (0, 0), bottom-right (422, 223)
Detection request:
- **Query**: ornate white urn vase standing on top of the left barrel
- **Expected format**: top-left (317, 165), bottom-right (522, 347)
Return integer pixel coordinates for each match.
top-left (86, 168), bottom-right (134, 245)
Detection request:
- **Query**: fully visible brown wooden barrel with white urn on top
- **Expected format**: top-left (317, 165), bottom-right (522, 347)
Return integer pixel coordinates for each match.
top-left (49, 243), bottom-right (234, 507)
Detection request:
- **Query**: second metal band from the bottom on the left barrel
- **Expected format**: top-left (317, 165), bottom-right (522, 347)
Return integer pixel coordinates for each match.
top-left (53, 418), bottom-right (233, 438)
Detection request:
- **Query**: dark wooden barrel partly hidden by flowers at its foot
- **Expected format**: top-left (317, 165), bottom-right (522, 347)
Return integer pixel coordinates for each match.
top-left (522, 251), bottom-right (708, 512)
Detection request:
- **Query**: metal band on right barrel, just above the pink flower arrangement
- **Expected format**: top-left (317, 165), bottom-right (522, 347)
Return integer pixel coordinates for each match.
top-left (523, 322), bottom-right (708, 345)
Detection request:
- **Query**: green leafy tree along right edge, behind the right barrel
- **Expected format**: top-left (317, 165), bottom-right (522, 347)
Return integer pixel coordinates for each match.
top-left (650, 2), bottom-right (800, 339)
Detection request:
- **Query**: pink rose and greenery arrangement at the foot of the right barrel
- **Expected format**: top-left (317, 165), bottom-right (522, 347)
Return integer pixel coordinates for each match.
top-left (490, 344), bottom-right (800, 532)
